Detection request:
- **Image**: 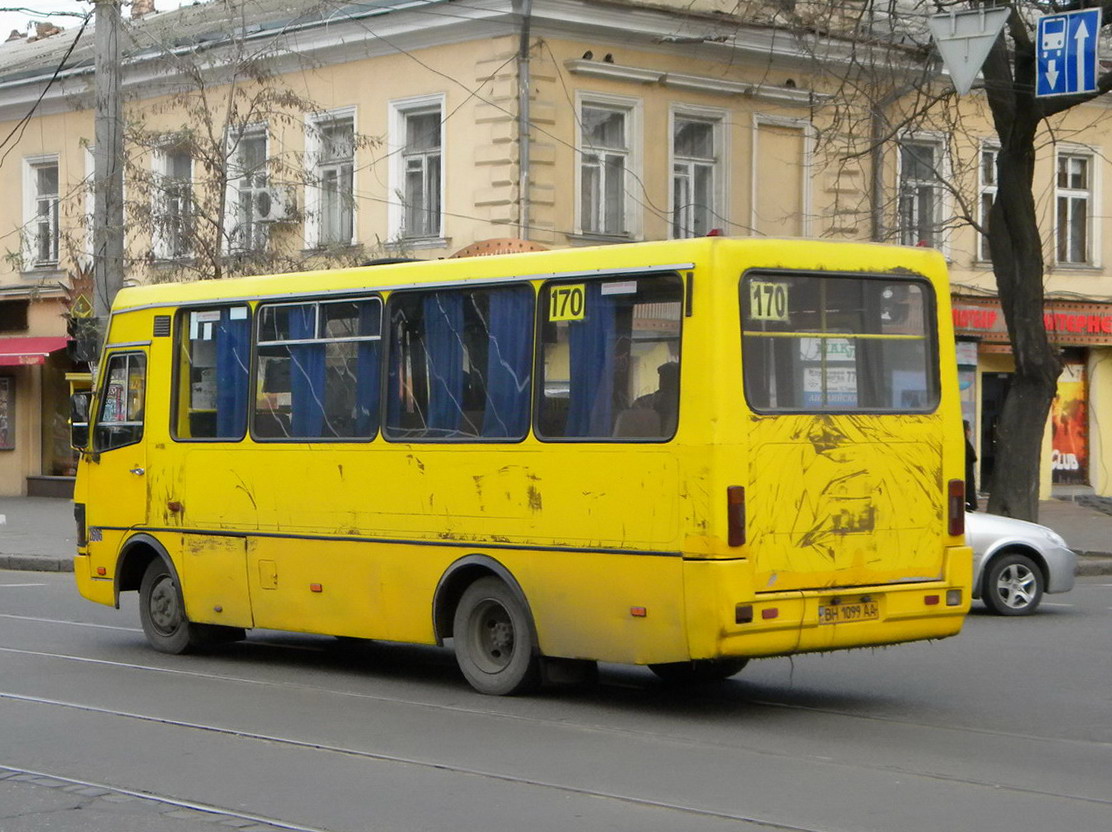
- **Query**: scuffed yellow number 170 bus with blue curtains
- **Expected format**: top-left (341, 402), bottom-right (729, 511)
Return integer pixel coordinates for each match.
top-left (75, 238), bottom-right (972, 694)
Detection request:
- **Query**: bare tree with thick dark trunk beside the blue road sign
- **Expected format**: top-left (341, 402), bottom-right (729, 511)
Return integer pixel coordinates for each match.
top-left (707, 0), bottom-right (1112, 519)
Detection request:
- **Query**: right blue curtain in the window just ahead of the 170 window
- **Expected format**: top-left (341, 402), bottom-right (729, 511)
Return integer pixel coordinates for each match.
top-left (483, 286), bottom-right (533, 438)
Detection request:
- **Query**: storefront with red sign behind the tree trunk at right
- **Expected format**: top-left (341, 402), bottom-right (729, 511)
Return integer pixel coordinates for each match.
top-left (953, 296), bottom-right (1112, 497)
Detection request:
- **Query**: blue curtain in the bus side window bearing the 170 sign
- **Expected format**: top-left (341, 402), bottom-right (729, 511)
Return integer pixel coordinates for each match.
top-left (564, 283), bottom-right (617, 436)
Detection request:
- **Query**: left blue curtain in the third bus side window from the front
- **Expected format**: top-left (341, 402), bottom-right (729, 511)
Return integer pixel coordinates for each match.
top-left (423, 291), bottom-right (465, 436)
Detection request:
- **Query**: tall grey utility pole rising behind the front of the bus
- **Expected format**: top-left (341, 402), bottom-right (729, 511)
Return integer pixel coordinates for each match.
top-left (92, 0), bottom-right (123, 346)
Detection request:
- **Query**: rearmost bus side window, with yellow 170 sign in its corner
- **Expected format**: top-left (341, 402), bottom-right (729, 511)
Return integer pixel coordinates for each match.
top-left (537, 275), bottom-right (683, 440)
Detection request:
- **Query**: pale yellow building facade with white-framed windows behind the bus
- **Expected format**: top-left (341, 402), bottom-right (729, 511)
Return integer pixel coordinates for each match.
top-left (0, 0), bottom-right (1112, 495)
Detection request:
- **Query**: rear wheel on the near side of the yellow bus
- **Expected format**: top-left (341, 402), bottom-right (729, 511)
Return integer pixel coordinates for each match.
top-left (451, 577), bottom-right (540, 696)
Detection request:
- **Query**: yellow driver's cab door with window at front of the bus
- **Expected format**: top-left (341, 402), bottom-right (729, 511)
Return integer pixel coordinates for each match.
top-left (86, 348), bottom-right (148, 562)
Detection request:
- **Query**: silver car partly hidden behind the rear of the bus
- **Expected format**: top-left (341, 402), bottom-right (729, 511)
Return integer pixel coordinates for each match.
top-left (965, 512), bottom-right (1078, 615)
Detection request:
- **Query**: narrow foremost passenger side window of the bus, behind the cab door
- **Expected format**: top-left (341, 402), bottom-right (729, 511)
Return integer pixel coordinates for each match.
top-left (173, 305), bottom-right (251, 439)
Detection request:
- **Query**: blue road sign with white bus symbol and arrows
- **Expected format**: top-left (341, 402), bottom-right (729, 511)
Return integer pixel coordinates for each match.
top-left (1035, 9), bottom-right (1101, 97)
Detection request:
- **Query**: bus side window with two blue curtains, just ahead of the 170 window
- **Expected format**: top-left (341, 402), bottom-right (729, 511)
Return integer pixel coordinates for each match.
top-left (385, 284), bottom-right (534, 439)
